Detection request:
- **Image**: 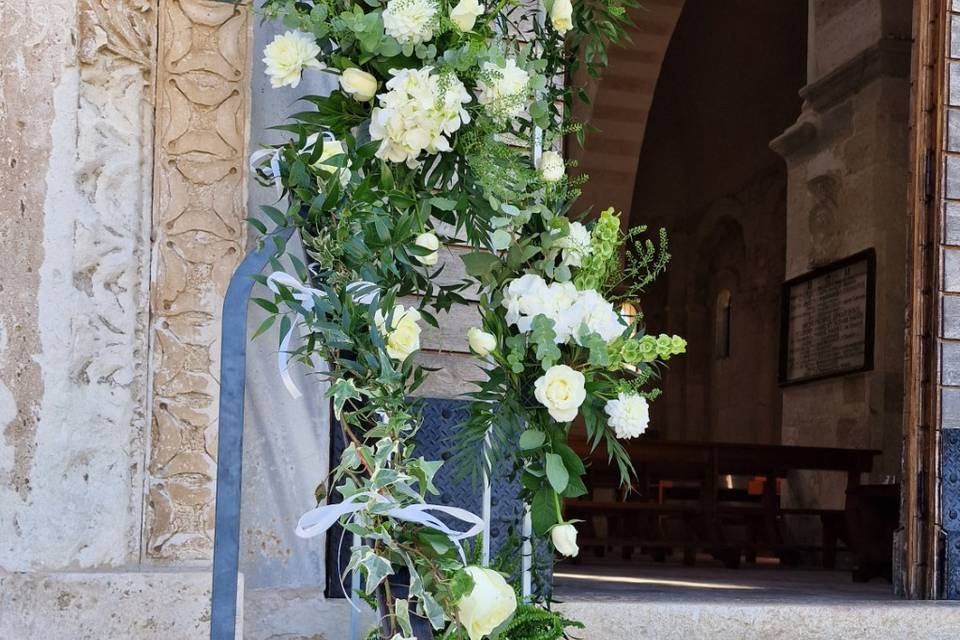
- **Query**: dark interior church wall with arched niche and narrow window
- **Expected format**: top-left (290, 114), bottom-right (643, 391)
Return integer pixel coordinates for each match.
top-left (628, 0), bottom-right (806, 443)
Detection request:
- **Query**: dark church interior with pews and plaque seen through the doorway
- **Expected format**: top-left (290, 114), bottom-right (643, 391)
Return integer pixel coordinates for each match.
top-left (555, 0), bottom-right (913, 598)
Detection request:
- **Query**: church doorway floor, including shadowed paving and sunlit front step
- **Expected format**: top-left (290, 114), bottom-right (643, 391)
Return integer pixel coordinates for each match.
top-left (554, 561), bottom-right (960, 640)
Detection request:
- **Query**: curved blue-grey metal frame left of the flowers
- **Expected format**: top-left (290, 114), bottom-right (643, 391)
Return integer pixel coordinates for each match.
top-left (210, 228), bottom-right (293, 640)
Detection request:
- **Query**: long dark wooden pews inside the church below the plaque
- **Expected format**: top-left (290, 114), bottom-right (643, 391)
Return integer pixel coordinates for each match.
top-left (565, 433), bottom-right (880, 568)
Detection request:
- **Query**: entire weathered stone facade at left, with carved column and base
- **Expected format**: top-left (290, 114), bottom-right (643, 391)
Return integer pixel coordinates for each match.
top-left (0, 0), bottom-right (249, 638)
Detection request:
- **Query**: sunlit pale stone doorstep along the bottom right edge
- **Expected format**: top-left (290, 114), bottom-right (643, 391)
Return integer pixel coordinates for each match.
top-left (557, 598), bottom-right (960, 640)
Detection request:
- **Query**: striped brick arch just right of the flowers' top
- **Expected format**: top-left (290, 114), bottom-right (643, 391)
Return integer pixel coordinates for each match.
top-left (568, 0), bottom-right (685, 221)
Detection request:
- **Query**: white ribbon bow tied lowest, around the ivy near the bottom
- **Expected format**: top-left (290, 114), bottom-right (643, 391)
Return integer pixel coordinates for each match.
top-left (296, 491), bottom-right (483, 564)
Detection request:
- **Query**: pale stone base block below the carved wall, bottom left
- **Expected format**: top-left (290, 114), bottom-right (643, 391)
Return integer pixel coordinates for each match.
top-left (0, 571), bottom-right (228, 640)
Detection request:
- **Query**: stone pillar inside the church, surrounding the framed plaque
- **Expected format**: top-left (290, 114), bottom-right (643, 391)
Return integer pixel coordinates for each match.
top-left (771, 0), bottom-right (911, 508)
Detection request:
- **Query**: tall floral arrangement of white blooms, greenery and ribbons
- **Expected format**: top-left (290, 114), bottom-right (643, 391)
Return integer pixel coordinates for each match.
top-left (226, 0), bottom-right (685, 640)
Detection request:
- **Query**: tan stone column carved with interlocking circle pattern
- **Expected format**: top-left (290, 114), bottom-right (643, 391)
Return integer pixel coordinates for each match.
top-left (144, 0), bottom-right (250, 560)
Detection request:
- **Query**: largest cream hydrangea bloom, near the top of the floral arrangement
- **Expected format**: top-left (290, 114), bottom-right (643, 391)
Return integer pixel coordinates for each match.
top-left (370, 67), bottom-right (471, 168)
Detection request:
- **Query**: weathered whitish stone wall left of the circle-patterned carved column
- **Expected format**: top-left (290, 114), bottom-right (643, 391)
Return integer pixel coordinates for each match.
top-left (0, 0), bottom-right (153, 570)
